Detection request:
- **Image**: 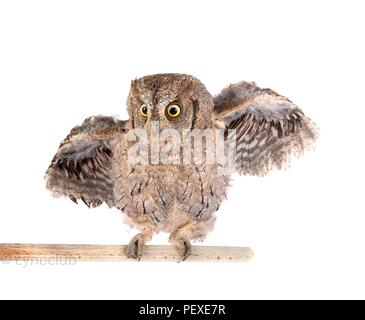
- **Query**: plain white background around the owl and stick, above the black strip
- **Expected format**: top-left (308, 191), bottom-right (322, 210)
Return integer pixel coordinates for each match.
top-left (0, 0), bottom-right (365, 299)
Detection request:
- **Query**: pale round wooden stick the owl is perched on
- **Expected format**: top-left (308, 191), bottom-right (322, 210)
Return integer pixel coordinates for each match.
top-left (0, 244), bottom-right (253, 262)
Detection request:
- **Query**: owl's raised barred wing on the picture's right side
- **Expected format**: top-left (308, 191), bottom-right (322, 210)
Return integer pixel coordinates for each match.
top-left (212, 82), bottom-right (318, 176)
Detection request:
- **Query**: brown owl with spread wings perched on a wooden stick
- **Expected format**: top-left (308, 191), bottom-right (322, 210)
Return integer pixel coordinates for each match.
top-left (45, 74), bottom-right (318, 260)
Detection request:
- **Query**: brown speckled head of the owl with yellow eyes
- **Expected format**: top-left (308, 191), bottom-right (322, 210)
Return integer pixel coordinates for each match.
top-left (127, 74), bottom-right (213, 129)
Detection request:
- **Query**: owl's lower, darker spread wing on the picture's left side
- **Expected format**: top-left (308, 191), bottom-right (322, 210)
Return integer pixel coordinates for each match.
top-left (45, 116), bottom-right (127, 207)
